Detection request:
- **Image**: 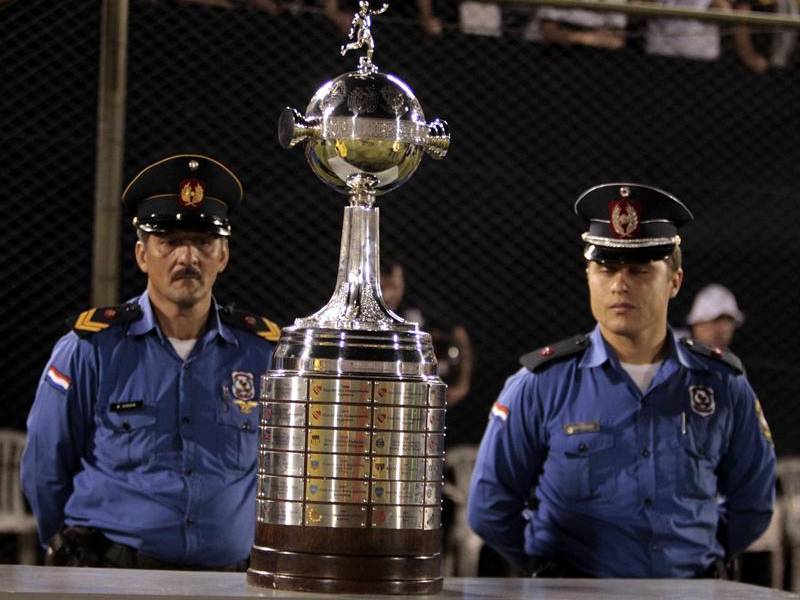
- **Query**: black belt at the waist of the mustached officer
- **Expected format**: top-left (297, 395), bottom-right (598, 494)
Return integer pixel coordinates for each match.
top-left (45, 525), bottom-right (249, 572)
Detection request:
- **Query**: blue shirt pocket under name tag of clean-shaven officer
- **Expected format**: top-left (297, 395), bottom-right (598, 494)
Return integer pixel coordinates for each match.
top-left (550, 431), bottom-right (616, 500)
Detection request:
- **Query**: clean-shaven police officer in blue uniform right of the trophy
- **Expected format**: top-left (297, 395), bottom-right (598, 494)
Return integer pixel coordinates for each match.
top-left (468, 183), bottom-right (775, 578)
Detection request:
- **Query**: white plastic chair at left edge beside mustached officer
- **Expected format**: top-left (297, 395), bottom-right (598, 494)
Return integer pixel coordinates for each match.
top-left (0, 429), bottom-right (36, 565)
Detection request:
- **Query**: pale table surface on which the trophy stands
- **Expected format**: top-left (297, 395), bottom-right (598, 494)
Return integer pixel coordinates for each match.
top-left (0, 565), bottom-right (800, 600)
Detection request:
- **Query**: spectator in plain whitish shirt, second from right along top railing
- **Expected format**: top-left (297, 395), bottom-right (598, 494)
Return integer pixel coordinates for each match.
top-left (645, 0), bottom-right (731, 60)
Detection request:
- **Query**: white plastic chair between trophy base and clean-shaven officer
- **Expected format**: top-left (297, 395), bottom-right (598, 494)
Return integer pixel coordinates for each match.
top-left (443, 445), bottom-right (483, 577)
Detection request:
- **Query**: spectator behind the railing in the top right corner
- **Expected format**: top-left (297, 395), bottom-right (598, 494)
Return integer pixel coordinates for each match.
top-left (733, 0), bottom-right (799, 73)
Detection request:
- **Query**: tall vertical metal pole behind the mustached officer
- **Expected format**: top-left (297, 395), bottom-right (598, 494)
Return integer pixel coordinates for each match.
top-left (92, 0), bottom-right (128, 306)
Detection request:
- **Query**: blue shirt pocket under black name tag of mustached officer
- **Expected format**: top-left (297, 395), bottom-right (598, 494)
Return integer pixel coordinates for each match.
top-left (96, 400), bottom-right (158, 470)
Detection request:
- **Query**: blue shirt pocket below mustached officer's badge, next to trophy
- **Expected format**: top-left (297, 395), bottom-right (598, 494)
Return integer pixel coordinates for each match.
top-left (216, 400), bottom-right (261, 472)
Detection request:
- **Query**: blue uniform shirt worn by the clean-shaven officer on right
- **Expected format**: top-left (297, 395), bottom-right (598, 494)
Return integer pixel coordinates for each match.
top-left (468, 327), bottom-right (775, 578)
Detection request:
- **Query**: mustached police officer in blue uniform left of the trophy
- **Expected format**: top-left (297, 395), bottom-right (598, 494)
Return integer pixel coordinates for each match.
top-left (22, 154), bottom-right (279, 570)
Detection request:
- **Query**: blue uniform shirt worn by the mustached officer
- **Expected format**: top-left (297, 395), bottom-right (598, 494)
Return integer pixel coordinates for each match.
top-left (22, 294), bottom-right (273, 567)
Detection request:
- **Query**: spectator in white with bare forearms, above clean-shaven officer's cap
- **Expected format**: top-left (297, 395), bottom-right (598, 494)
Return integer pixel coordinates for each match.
top-left (536, 6), bottom-right (628, 50)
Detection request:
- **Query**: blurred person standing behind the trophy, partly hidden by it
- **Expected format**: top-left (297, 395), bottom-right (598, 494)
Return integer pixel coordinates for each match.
top-left (381, 257), bottom-right (473, 408)
